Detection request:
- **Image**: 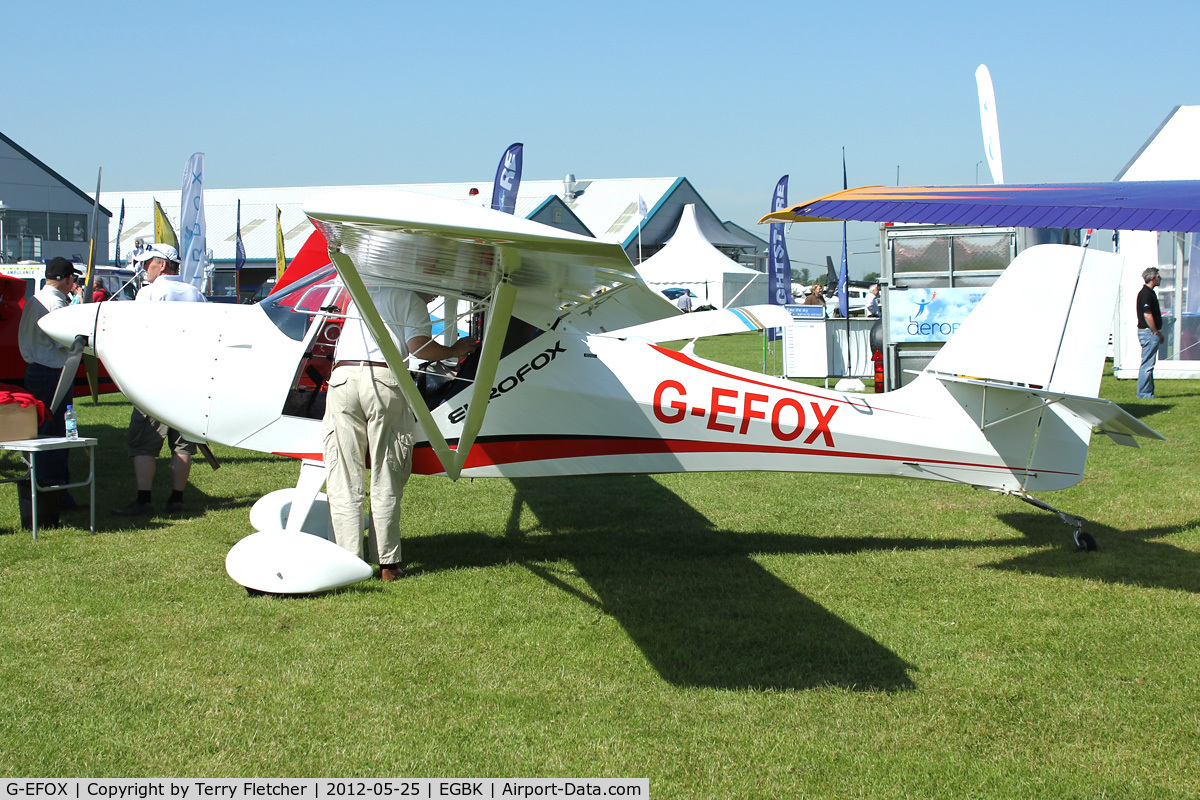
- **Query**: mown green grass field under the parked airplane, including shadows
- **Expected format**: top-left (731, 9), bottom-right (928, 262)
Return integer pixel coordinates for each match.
top-left (0, 337), bottom-right (1200, 798)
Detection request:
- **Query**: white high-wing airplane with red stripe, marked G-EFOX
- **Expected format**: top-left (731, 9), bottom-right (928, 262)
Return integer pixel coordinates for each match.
top-left (42, 185), bottom-right (1162, 594)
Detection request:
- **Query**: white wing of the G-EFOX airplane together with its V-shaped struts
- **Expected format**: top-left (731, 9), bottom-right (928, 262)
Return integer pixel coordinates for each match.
top-left (304, 190), bottom-right (676, 479)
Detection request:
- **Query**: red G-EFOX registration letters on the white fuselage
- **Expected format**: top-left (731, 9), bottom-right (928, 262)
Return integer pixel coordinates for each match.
top-left (654, 380), bottom-right (838, 447)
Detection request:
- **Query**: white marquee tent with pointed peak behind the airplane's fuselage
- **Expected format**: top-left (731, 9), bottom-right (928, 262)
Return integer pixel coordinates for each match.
top-left (637, 204), bottom-right (767, 308)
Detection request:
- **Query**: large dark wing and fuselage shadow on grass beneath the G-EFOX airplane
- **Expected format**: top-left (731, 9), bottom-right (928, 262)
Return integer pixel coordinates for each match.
top-left (413, 476), bottom-right (934, 691)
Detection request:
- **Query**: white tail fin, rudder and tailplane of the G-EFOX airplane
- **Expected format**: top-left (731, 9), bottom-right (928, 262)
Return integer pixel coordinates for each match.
top-left (926, 245), bottom-right (1162, 491)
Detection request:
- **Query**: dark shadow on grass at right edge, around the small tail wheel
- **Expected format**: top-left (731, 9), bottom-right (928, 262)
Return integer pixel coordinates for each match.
top-left (991, 512), bottom-right (1200, 593)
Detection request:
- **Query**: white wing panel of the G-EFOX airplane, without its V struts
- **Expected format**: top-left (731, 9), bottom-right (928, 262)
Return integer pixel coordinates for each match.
top-left (304, 190), bottom-right (652, 329)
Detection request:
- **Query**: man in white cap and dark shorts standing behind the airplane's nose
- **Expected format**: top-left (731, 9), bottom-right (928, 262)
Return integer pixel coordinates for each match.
top-left (113, 242), bottom-right (205, 517)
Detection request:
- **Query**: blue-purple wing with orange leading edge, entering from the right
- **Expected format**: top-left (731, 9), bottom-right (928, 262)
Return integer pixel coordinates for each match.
top-left (758, 181), bottom-right (1200, 230)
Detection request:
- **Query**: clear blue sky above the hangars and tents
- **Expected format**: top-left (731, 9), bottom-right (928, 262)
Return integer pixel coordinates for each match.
top-left (0, 0), bottom-right (1200, 280)
